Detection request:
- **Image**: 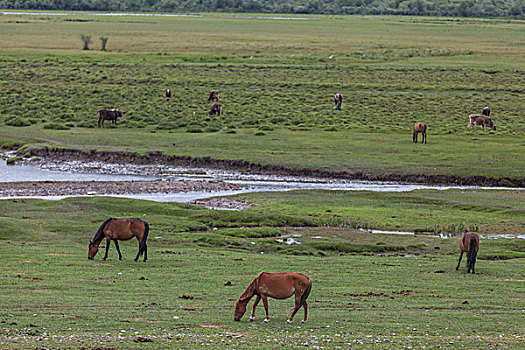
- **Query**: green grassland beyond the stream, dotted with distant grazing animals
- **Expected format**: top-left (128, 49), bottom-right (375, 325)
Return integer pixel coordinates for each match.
top-left (0, 15), bottom-right (525, 178)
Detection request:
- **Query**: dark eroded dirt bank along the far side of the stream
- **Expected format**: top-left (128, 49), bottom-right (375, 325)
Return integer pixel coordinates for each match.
top-left (25, 147), bottom-right (525, 187)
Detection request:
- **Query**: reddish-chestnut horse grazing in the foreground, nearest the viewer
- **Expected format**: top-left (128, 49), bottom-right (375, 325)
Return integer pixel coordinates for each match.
top-left (233, 272), bottom-right (312, 323)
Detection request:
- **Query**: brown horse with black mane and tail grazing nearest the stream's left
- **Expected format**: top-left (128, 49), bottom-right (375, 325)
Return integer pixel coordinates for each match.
top-left (88, 218), bottom-right (149, 262)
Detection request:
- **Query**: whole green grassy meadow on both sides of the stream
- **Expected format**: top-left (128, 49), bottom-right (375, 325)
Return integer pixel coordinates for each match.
top-left (0, 10), bottom-right (525, 349)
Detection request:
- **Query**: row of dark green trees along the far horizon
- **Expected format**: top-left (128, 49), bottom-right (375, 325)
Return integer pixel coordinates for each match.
top-left (0, 0), bottom-right (525, 19)
